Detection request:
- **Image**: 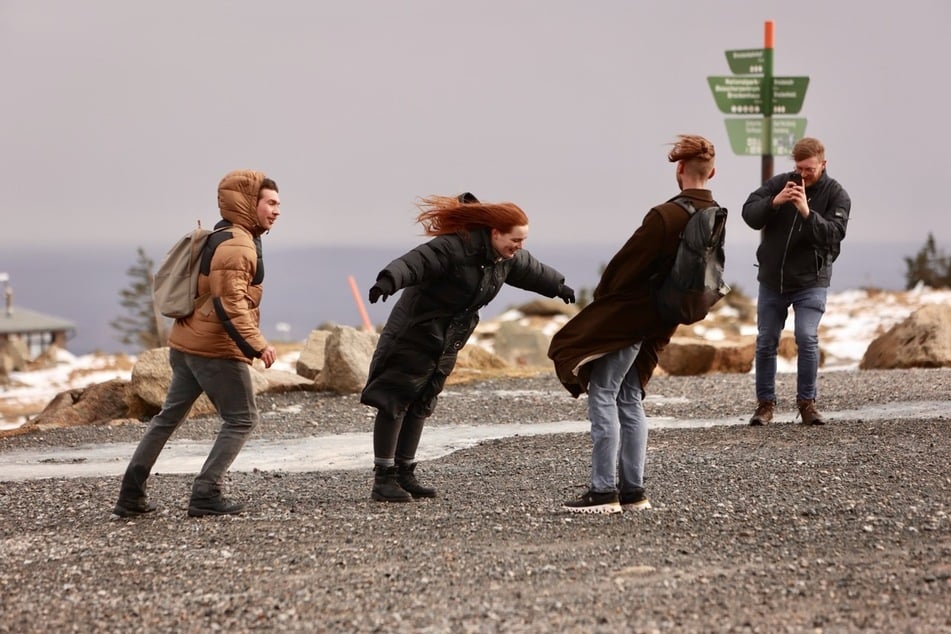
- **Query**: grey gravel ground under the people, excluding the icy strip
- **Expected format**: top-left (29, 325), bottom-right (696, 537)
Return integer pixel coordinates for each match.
top-left (0, 369), bottom-right (951, 632)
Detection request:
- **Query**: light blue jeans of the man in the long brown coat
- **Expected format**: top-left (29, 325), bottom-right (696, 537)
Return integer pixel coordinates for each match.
top-left (588, 343), bottom-right (647, 493)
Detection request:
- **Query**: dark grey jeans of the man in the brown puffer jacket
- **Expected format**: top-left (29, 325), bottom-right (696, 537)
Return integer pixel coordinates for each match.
top-left (119, 349), bottom-right (258, 504)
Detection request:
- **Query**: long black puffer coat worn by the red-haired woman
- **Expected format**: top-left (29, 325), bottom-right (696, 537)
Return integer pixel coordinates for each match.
top-left (360, 229), bottom-right (565, 416)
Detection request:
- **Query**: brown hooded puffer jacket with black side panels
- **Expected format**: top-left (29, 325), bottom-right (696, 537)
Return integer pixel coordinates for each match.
top-left (168, 170), bottom-right (267, 363)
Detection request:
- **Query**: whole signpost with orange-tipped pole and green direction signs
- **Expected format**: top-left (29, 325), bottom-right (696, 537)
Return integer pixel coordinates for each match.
top-left (707, 20), bottom-right (809, 182)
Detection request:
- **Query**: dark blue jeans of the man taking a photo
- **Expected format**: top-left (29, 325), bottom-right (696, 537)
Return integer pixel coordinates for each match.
top-left (756, 284), bottom-right (829, 401)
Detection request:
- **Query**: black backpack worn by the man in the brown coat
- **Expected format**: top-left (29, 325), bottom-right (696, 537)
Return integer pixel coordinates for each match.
top-left (653, 196), bottom-right (730, 325)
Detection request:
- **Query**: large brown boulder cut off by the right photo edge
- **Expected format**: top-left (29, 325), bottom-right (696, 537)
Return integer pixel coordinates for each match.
top-left (859, 304), bottom-right (951, 370)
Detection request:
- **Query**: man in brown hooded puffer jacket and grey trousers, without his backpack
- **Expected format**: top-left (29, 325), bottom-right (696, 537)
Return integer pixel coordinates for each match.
top-left (113, 170), bottom-right (281, 517)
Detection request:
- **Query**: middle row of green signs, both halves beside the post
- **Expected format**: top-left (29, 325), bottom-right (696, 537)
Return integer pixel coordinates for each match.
top-left (707, 76), bottom-right (809, 114)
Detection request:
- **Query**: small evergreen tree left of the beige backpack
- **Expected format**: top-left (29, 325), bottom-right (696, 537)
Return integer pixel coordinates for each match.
top-left (109, 247), bottom-right (168, 350)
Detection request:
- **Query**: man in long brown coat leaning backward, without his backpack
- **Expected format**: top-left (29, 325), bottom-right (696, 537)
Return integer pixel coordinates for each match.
top-left (548, 135), bottom-right (716, 513)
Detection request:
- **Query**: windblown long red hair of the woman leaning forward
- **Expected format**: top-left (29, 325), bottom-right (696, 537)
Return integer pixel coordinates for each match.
top-left (416, 196), bottom-right (528, 236)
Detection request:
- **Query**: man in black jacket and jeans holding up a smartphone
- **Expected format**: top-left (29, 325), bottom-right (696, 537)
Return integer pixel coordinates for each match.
top-left (743, 137), bottom-right (852, 425)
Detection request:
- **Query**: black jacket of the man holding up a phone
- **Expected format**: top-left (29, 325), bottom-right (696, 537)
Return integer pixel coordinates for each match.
top-left (743, 171), bottom-right (852, 293)
